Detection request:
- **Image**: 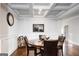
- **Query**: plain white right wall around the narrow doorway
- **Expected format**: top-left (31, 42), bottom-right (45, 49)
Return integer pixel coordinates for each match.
top-left (62, 15), bottom-right (79, 45)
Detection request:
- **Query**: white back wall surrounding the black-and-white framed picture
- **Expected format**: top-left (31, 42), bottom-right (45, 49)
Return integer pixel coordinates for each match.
top-left (18, 17), bottom-right (58, 40)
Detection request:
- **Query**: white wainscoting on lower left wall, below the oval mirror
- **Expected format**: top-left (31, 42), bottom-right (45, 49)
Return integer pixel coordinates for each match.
top-left (0, 34), bottom-right (17, 55)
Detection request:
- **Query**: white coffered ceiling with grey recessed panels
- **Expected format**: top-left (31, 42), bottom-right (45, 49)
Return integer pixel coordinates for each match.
top-left (8, 3), bottom-right (76, 18)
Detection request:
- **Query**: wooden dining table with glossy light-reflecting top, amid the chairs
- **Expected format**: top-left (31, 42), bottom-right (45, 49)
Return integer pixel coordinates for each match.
top-left (29, 39), bottom-right (57, 56)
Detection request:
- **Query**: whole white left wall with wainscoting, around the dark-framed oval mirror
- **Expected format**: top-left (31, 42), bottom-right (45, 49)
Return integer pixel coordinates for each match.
top-left (0, 4), bottom-right (17, 55)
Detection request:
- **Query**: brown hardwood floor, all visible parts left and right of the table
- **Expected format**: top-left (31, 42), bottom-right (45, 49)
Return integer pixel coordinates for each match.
top-left (11, 42), bottom-right (79, 56)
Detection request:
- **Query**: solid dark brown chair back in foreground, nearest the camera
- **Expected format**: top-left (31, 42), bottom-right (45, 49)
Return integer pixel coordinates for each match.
top-left (44, 40), bottom-right (58, 56)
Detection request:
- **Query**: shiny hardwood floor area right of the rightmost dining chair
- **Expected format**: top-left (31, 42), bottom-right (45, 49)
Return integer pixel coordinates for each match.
top-left (64, 42), bottom-right (79, 56)
